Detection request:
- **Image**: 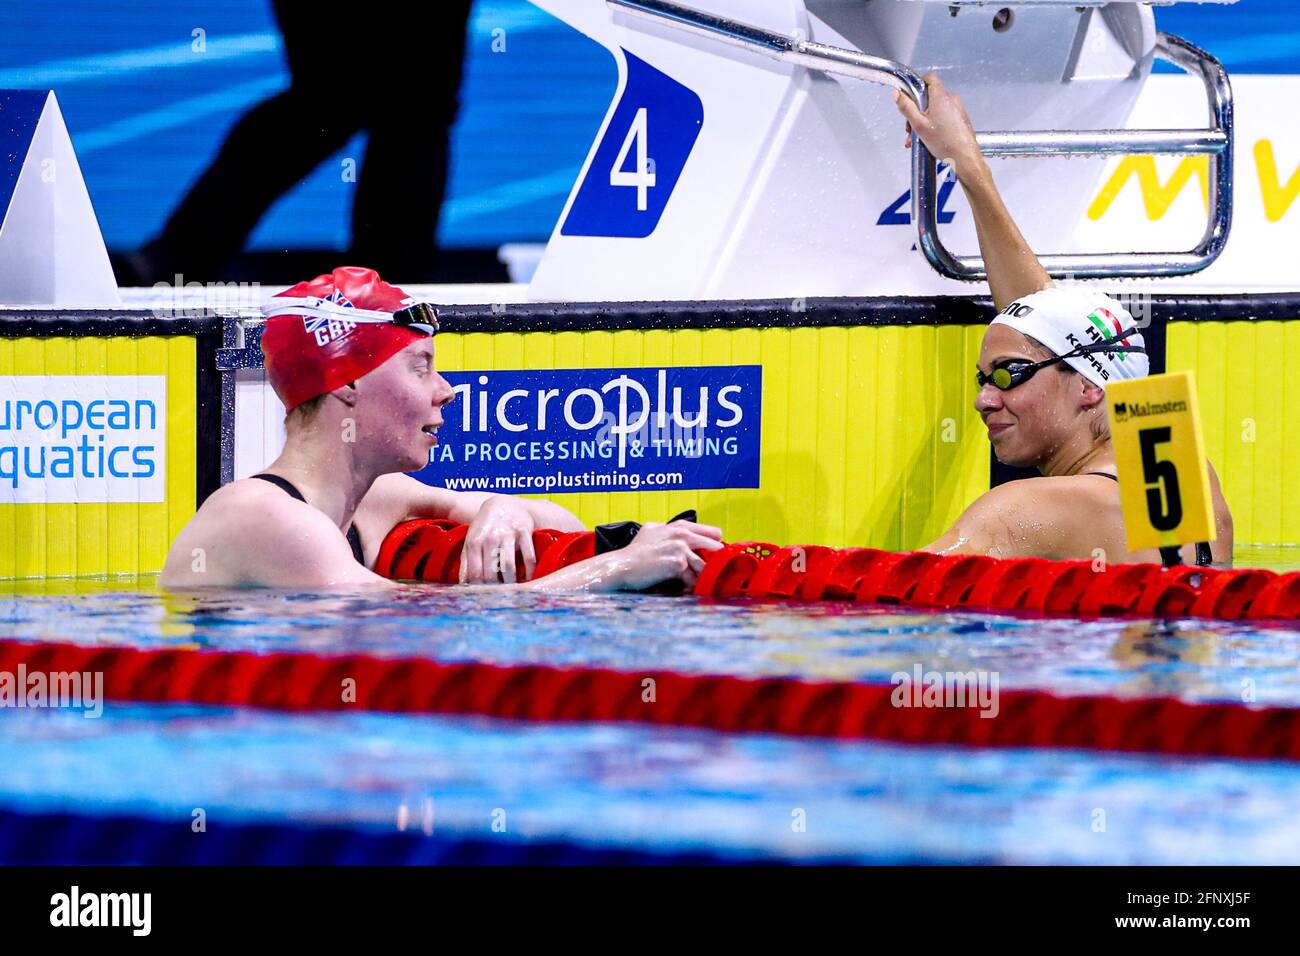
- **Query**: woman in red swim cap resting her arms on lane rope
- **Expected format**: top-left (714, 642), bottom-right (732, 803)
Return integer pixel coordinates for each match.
top-left (160, 267), bottom-right (722, 591)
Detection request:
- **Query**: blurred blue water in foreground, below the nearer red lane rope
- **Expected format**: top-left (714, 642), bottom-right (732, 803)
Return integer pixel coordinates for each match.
top-left (0, 705), bottom-right (1300, 864)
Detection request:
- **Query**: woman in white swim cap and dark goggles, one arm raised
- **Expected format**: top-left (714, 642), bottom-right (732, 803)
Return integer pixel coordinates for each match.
top-left (894, 74), bottom-right (1232, 566)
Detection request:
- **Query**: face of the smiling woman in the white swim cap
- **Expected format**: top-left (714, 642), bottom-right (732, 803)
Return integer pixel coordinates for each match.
top-left (975, 324), bottom-right (1105, 467)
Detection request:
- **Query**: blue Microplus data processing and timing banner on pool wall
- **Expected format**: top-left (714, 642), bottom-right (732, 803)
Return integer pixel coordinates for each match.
top-left (419, 365), bottom-right (763, 493)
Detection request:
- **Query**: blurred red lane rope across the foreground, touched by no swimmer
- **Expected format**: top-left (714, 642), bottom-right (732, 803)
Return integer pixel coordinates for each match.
top-left (0, 640), bottom-right (1300, 760)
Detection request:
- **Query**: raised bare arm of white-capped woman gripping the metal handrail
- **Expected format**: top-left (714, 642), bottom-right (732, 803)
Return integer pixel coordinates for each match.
top-left (894, 73), bottom-right (1052, 312)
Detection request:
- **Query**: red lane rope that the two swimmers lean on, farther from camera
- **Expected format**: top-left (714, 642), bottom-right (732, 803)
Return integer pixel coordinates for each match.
top-left (374, 519), bottom-right (1300, 620)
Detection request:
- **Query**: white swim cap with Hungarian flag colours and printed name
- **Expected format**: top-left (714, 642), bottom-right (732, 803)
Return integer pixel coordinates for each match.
top-left (989, 286), bottom-right (1151, 389)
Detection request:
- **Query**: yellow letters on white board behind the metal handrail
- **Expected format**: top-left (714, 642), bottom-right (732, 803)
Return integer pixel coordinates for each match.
top-left (1088, 139), bottom-right (1300, 222)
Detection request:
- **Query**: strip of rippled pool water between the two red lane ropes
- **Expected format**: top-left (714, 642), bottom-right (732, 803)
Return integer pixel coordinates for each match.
top-left (0, 580), bottom-right (1300, 705)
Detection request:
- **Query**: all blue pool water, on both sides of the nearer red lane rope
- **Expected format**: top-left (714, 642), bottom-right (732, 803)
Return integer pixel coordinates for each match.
top-left (0, 548), bottom-right (1300, 864)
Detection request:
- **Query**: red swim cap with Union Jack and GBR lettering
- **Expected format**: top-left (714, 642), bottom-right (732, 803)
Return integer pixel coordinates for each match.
top-left (261, 265), bottom-right (425, 411)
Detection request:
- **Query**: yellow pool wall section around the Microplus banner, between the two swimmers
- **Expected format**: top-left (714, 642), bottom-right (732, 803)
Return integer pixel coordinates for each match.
top-left (437, 325), bottom-right (988, 549)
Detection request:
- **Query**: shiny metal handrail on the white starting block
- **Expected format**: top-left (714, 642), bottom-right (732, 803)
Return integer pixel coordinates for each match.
top-left (606, 0), bottom-right (1234, 281)
